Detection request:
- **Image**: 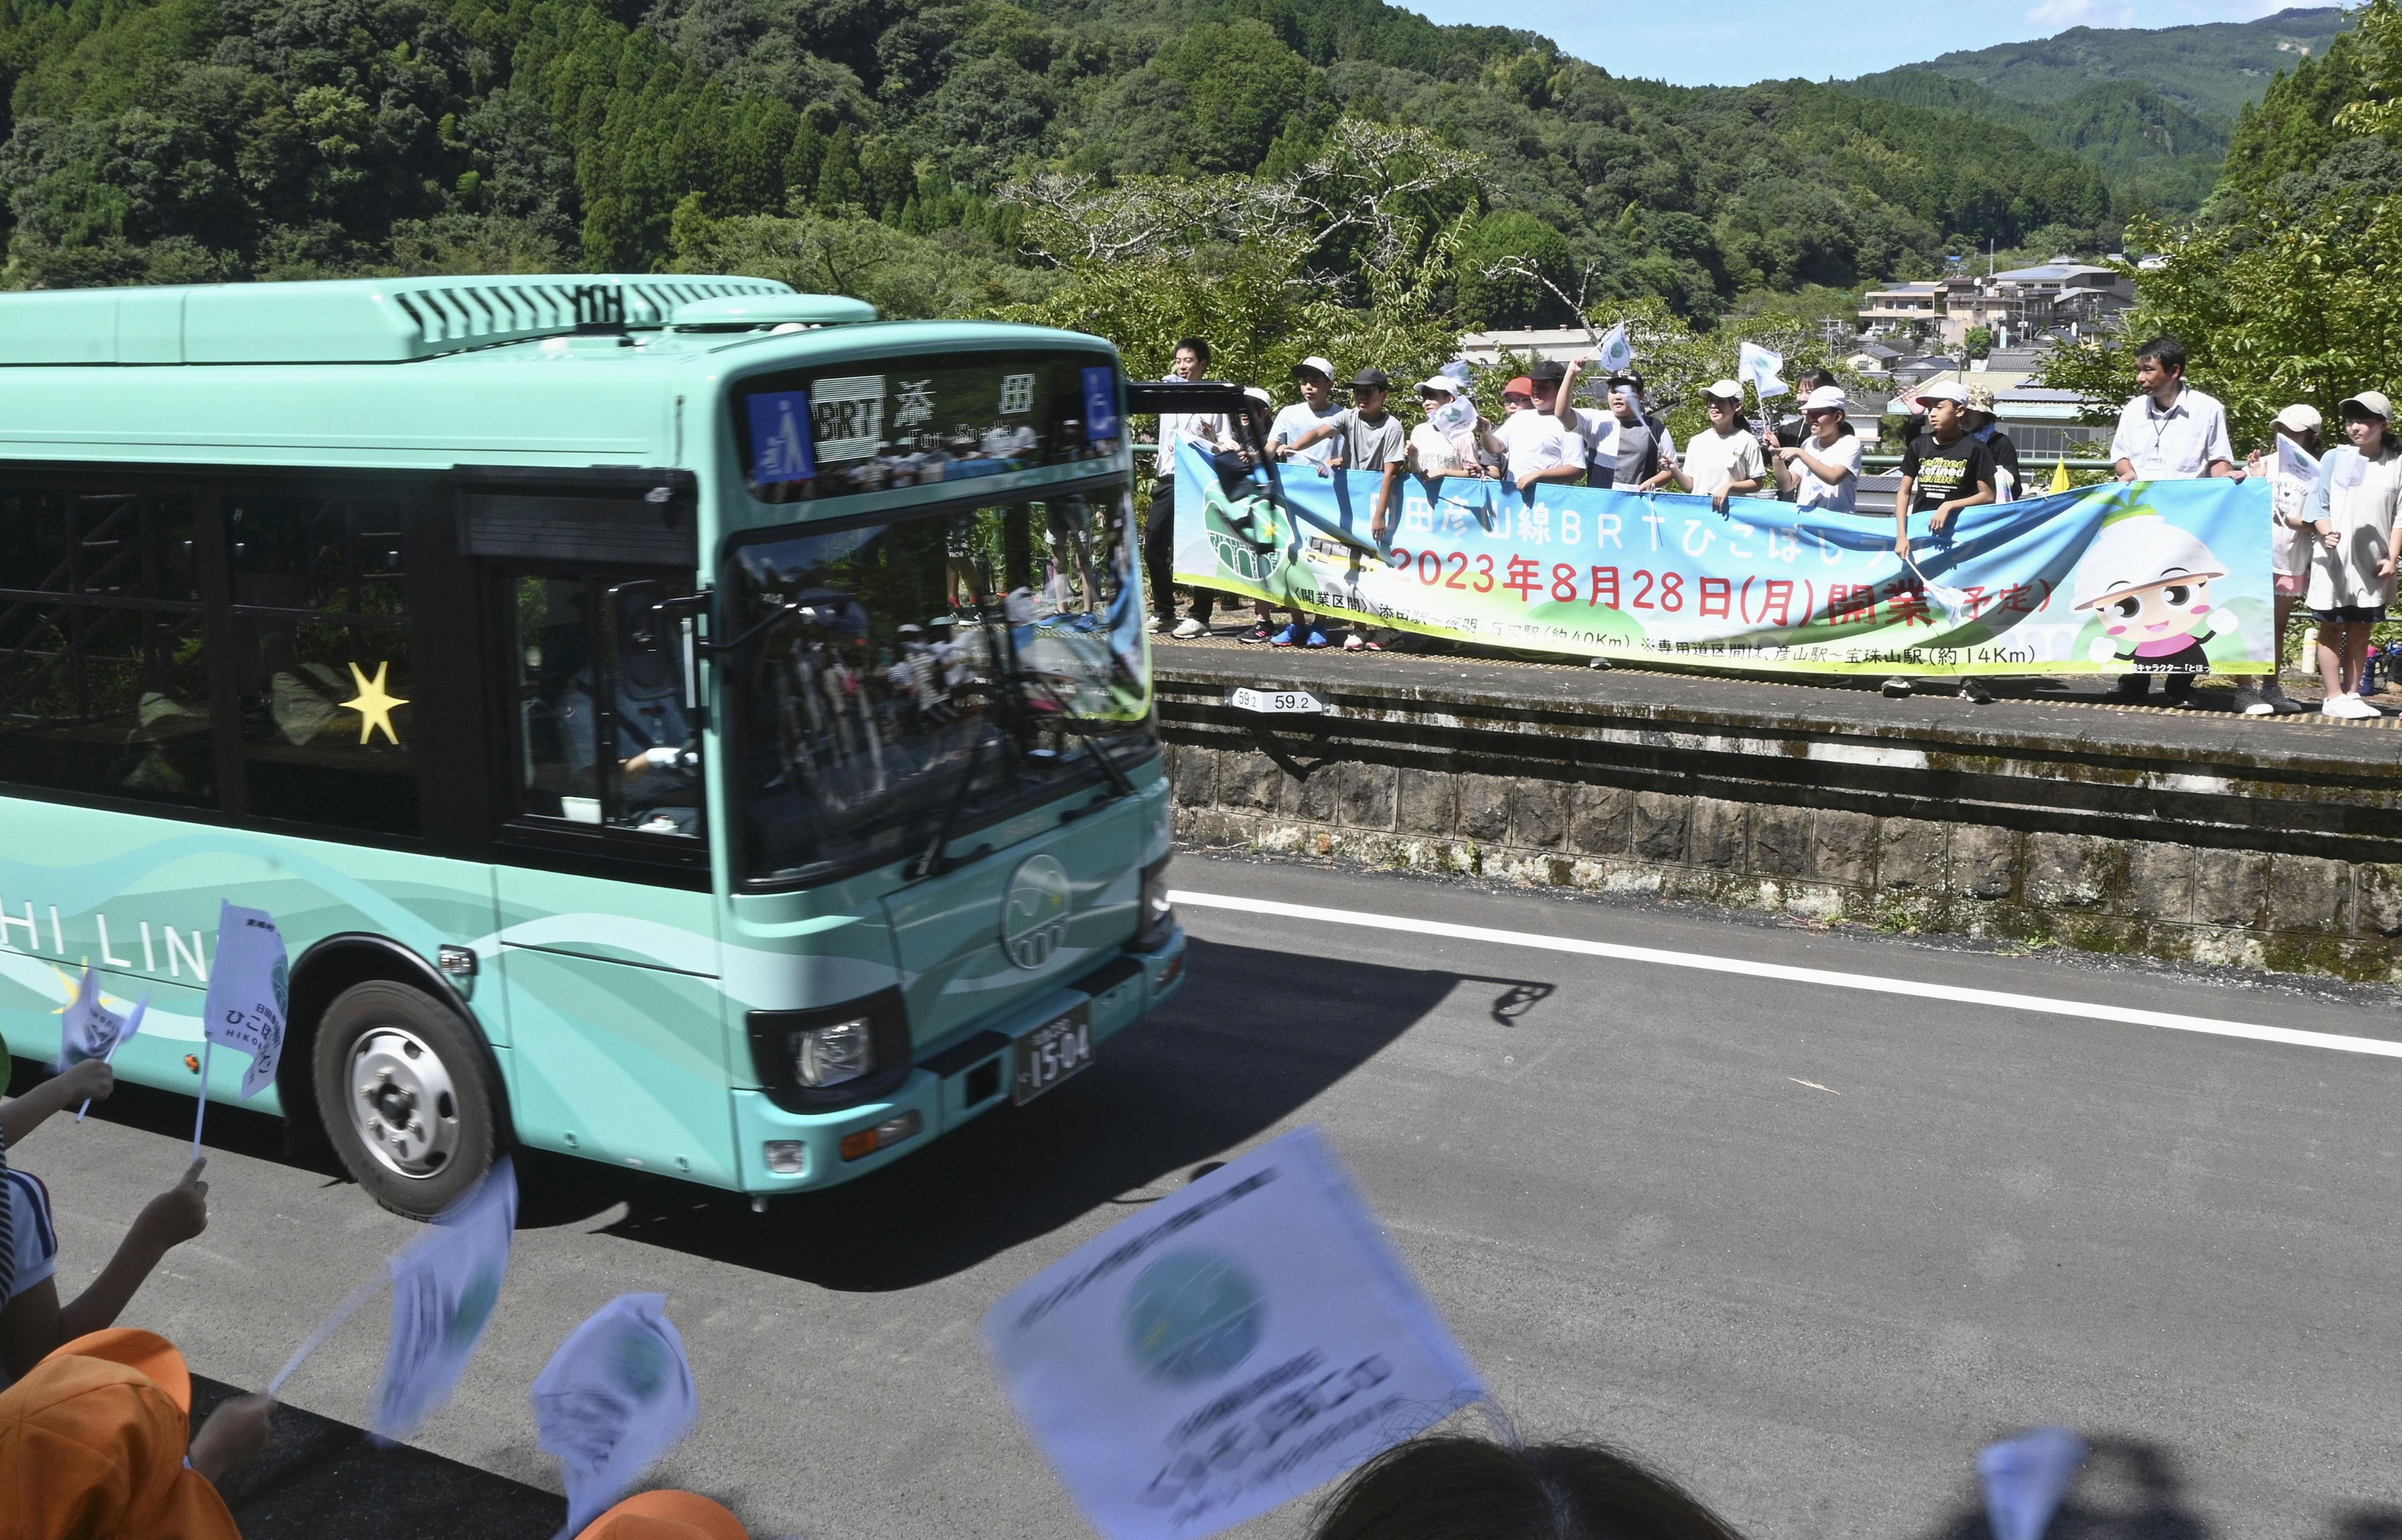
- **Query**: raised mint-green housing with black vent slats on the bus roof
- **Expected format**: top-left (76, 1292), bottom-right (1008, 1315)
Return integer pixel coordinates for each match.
top-left (0, 274), bottom-right (807, 365)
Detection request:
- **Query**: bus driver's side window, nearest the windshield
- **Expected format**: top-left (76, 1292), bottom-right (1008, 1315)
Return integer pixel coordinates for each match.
top-left (509, 577), bottom-right (706, 841)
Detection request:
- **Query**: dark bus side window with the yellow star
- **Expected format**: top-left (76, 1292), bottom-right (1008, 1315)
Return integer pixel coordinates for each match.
top-left (223, 493), bottom-right (418, 834)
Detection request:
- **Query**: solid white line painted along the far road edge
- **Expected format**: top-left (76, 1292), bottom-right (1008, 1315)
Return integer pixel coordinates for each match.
top-left (1167, 889), bottom-right (2402, 1059)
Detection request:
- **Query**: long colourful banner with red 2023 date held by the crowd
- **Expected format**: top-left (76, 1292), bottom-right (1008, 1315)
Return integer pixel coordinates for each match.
top-left (1174, 439), bottom-right (2275, 675)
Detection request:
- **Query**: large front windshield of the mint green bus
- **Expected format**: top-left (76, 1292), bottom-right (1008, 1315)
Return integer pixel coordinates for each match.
top-left (732, 490), bottom-right (1156, 884)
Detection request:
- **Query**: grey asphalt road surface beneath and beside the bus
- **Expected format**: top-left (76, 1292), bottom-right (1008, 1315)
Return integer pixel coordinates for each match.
top-left (15, 858), bottom-right (2402, 1540)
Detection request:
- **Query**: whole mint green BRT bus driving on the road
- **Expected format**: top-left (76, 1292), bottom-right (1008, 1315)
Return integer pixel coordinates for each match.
top-left (0, 276), bottom-right (1184, 1216)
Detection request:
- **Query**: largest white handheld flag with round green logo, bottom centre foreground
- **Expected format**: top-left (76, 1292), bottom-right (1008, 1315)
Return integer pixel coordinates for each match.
top-left (985, 1129), bottom-right (1484, 1540)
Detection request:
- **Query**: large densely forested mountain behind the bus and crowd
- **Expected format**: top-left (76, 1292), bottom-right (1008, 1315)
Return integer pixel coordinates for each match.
top-left (0, 0), bottom-right (2119, 322)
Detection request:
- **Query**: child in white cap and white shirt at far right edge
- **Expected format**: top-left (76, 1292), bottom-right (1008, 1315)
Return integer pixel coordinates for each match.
top-left (2306, 389), bottom-right (2402, 719)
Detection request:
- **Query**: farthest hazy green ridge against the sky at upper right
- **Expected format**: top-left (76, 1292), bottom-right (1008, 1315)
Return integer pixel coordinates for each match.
top-left (1917, 5), bottom-right (2347, 120)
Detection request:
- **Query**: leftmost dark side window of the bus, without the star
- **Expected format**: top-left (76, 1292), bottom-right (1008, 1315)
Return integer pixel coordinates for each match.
top-left (0, 488), bottom-right (216, 808)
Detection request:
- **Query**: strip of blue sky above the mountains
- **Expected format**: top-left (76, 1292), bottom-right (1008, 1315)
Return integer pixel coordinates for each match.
top-left (1395, 0), bottom-right (2296, 87)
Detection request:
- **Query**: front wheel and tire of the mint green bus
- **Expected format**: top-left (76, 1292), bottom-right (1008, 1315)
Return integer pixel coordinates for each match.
top-left (315, 978), bottom-right (499, 1218)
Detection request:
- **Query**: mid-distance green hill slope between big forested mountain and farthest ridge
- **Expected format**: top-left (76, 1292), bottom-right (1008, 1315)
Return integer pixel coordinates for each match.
top-left (1842, 65), bottom-right (2234, 214)
